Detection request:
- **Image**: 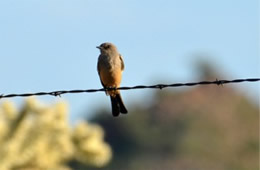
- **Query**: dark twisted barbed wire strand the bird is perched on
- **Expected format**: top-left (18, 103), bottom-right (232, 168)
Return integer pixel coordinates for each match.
top-left (0, 78), bottom-right (260, 99)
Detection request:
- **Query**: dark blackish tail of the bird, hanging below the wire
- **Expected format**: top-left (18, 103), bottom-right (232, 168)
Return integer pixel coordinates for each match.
top-left (110, 93), bottom-right (127, 116)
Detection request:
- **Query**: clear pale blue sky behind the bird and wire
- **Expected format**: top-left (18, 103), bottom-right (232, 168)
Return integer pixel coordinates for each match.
top-left (0, 0), bottom-right (260, 122)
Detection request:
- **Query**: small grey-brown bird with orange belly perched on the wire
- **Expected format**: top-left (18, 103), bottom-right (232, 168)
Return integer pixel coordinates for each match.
top-left (97, 42), bottom-right (127, 116)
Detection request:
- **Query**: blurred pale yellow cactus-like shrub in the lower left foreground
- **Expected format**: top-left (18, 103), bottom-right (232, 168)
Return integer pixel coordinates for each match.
top-left (0, 98), bottom-right (112, 170)
